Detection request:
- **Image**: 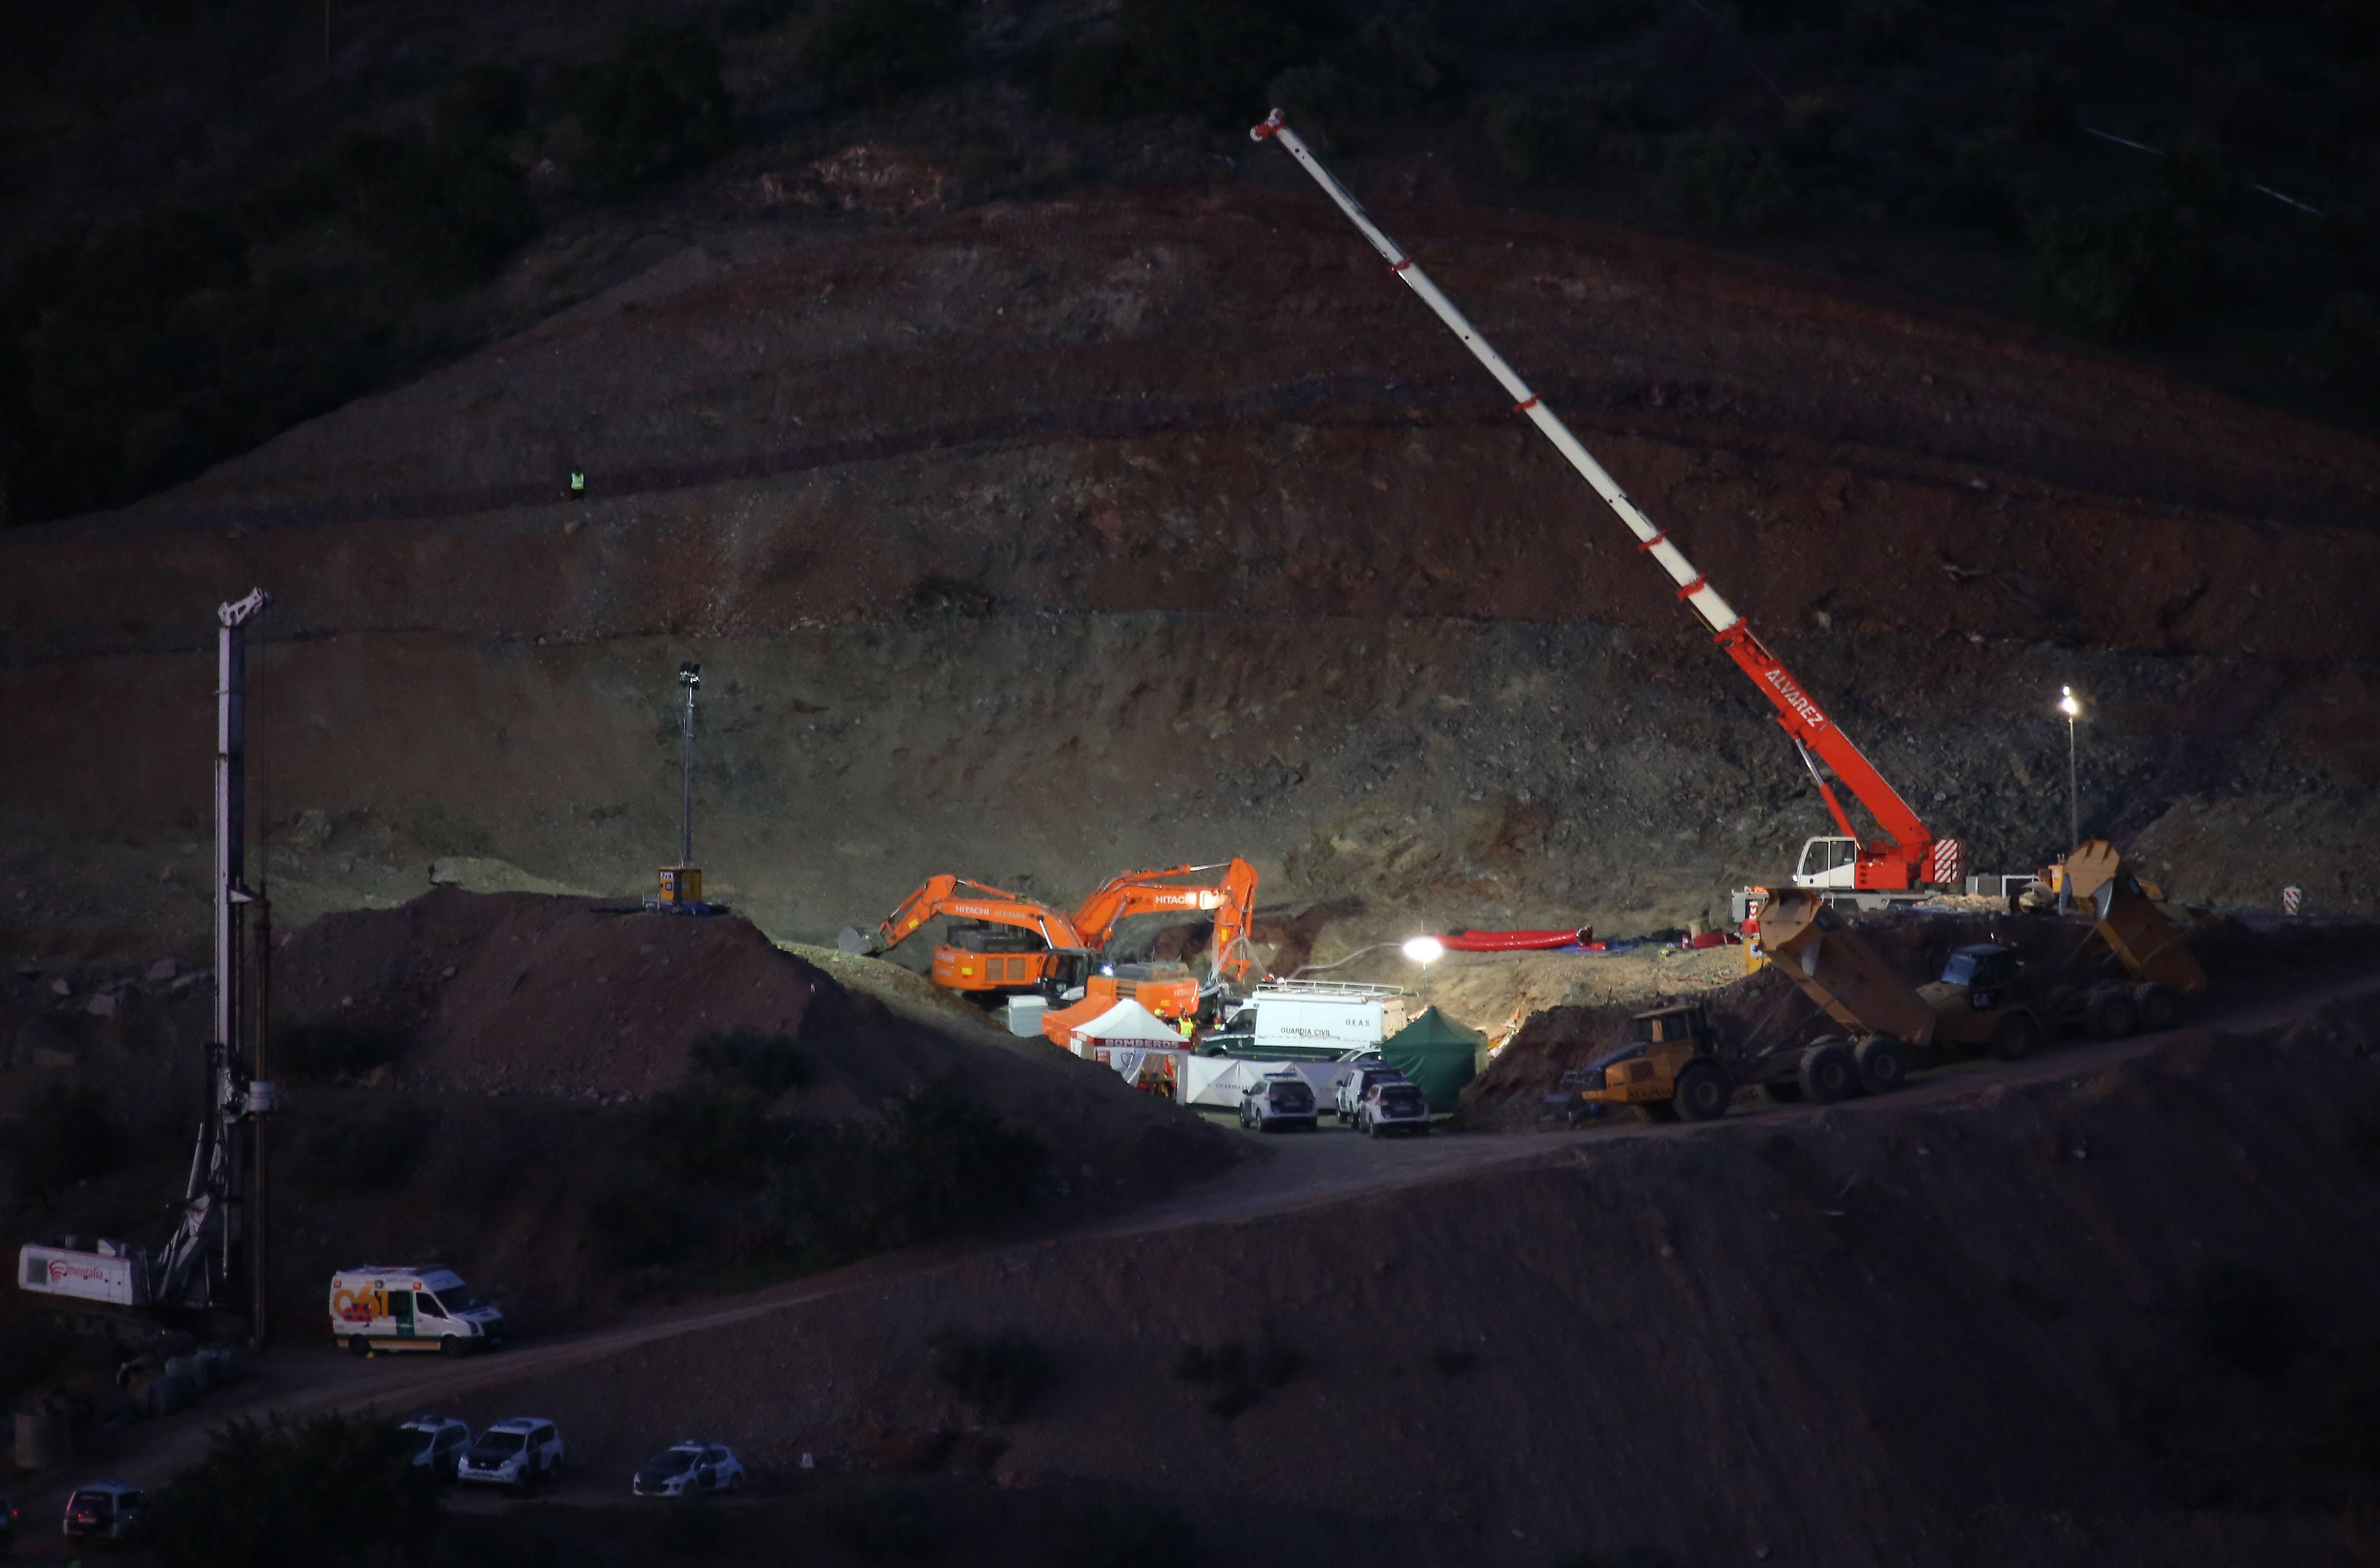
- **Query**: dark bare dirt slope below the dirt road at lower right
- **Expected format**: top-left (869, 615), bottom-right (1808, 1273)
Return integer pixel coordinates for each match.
top-left (424, 999), bottom-right (2380, 1566)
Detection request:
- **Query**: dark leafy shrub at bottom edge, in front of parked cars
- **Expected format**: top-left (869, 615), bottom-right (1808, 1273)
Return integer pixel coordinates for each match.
top-left (140, 1416), bottom-right (440, 1568)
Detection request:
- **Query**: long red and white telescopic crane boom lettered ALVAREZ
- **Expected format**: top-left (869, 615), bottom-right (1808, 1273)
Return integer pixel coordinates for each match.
top-left (1250, 109), bottom-right (1959, 871)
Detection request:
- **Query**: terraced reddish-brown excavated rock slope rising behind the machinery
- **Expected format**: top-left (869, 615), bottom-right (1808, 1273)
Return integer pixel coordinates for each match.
top-left (0, 188), bottom-right (2380, 980)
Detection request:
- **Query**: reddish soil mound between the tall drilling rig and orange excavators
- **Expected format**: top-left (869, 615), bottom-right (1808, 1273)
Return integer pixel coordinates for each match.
top-left (276, 887), bottom-right (1228, 1166)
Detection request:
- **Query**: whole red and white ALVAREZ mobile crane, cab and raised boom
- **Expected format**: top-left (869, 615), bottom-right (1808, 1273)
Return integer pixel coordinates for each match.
top-left (1250, 109), bottom-right (1966, 904)
